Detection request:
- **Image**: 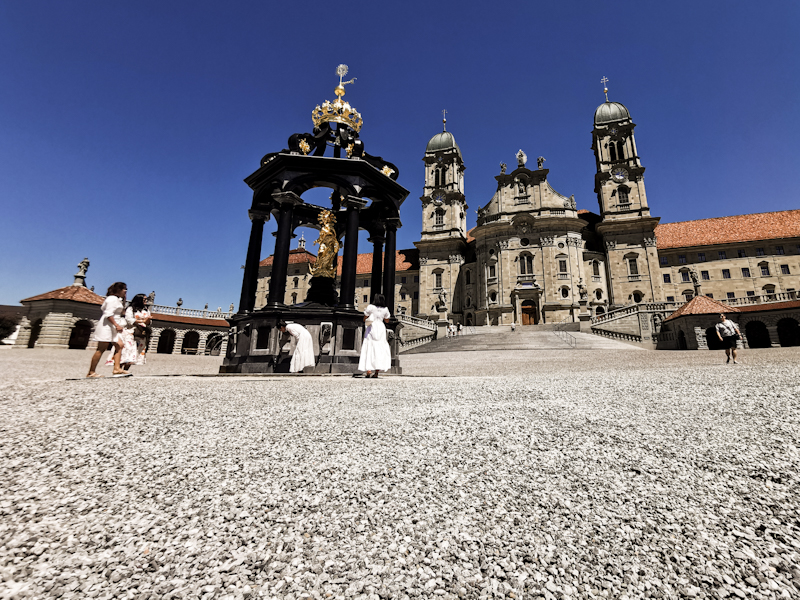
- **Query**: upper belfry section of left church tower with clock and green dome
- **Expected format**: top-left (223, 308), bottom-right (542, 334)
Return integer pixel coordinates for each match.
top-left (420, 111), bottom-right (468, 239)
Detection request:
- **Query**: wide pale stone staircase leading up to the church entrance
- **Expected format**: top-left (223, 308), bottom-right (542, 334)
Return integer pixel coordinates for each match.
top-left (401, 324), bottom-right (641, 355)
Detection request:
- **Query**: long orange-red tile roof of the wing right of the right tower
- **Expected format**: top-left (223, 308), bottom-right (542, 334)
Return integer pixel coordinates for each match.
top-left (656, 210), bottom-right (800, 250)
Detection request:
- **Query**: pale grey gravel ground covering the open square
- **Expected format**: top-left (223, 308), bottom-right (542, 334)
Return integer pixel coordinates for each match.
top-left (0, 348), bottom-right (800, 600)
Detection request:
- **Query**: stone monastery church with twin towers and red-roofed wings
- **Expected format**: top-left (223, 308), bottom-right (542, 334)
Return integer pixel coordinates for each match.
top-left (257, 96), bottom-right (800, 325)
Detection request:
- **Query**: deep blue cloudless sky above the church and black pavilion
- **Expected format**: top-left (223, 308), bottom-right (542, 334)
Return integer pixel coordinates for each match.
top-left (0, 0), bottom-right (800, 308)
